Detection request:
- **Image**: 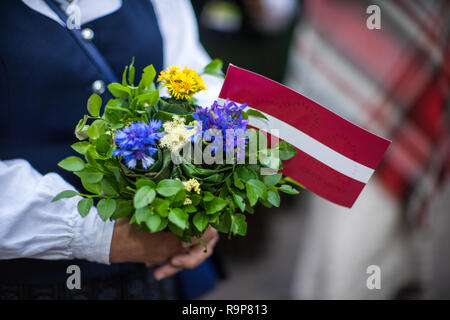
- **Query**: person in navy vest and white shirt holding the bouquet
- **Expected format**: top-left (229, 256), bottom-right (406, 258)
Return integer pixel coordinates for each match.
top-left (0, 0), bottom-right (221, 299)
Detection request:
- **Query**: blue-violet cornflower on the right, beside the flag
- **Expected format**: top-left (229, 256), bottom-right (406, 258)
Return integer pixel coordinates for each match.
top-left (192, 100), bottom-right (248, 156)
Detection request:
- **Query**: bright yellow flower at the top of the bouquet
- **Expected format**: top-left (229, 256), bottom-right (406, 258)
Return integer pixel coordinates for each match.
top-left (158, 66), bottom-right (206, 100)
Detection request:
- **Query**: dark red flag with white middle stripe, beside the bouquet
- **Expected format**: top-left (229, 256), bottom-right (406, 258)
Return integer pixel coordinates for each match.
top-left (219, 65), bottom-right (391, 207)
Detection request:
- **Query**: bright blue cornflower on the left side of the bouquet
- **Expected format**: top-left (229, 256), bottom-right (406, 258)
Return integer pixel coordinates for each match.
top-left (113, 120), bottom-right (164, 169)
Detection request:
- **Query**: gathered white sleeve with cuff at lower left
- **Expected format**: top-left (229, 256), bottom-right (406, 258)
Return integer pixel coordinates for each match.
top-left (0, 160), bottom-right (114, 264)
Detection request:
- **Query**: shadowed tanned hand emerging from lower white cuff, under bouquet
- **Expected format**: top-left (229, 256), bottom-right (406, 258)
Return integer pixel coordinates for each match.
top-left (109, 218), bottom-right (185, 265)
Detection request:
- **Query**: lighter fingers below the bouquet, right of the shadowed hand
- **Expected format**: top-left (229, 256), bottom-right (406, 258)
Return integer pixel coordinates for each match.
top-left (153, 226), bottom-right (219, 280)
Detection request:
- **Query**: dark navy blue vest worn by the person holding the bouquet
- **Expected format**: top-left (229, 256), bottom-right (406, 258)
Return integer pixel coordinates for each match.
top-left (0, 0), bottom-right (163, 284)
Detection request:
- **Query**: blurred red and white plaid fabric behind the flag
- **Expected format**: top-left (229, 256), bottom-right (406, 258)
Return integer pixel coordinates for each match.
top-left (287, 0), bottom-right (450, 225)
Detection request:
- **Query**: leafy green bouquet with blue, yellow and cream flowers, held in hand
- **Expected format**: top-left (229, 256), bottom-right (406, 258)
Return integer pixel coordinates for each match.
top-left (53, 59), bottom-right (298, 242)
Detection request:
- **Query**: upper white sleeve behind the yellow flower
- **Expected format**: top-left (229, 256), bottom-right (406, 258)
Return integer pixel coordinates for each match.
top-left (151, 0), bottom-right (223, 107)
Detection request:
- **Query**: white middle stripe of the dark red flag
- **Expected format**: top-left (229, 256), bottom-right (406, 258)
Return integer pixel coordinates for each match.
top-left (218, 98), bottom-right (375, 183)
